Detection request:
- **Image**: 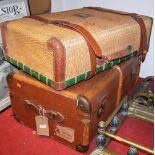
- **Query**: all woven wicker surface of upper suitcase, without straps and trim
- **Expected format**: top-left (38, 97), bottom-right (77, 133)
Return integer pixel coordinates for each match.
top-left (6, 8), bottom-right (151, 83)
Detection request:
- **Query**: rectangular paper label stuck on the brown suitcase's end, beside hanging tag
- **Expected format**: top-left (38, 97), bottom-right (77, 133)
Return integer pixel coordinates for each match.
top-left (55, 125), bottom-right (75, 143)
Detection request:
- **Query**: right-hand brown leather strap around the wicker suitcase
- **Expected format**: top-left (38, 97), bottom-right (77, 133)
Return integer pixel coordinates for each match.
top-left (86, 7), bottom-right (147, 61)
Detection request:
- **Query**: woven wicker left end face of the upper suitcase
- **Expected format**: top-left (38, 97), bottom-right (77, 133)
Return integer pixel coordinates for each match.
top-left (7, 21), bottom-right (53, 79)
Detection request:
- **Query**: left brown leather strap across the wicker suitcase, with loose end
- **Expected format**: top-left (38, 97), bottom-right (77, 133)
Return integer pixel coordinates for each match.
top-left (30, 16), bottom-right (107, 75)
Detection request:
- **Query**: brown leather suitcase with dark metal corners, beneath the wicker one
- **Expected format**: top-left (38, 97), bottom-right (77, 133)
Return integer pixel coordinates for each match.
top-left (7, 57), bottom-right (141, 152)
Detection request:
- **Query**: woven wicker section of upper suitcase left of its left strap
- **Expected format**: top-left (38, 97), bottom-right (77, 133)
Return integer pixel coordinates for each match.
top-left (6, 19), bottom-right (91, 80)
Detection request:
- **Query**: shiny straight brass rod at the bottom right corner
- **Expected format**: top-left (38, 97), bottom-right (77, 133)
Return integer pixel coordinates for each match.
top-left (105, 132), bottom-right (154, 154)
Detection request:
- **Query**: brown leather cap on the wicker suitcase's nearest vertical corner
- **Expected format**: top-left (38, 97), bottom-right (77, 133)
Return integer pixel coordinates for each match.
top-left (47, 37), bottom-right (66, 83)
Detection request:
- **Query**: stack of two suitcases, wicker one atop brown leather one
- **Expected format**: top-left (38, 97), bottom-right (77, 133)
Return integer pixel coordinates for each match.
top-left (2, 7), bottom-right (152, 152)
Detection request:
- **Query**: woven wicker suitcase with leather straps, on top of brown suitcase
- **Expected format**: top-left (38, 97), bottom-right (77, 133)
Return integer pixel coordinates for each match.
top-left (2, 7), bottom-right (152, 90)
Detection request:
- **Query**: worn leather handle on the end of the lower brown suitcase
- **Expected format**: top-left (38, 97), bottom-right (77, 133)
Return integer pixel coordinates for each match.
top-left (24, 100), bottom-right (64, 123)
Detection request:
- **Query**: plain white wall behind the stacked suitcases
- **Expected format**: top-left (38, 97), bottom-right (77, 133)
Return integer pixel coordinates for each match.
top-left (53, 0), bottom-right (154, 77)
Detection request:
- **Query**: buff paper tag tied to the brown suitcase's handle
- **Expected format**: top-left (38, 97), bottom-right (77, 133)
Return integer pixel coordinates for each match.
top-left (35, 106), bottom-right (49, 136)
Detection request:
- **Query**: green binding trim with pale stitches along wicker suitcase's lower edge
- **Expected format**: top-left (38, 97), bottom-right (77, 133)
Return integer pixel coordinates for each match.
top-left (5, 51), bottom-right (138, 88)
